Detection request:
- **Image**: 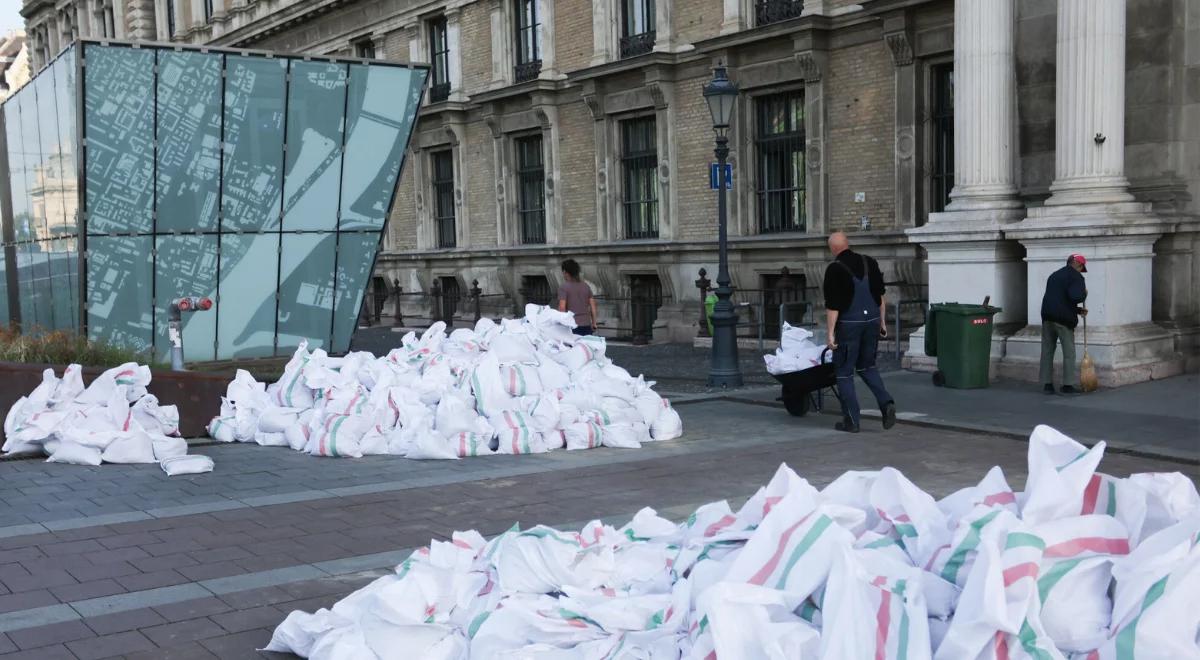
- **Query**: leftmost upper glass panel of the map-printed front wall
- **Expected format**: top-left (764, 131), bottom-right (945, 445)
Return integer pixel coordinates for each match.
top-left (84, 44), bottom-right (154, 234)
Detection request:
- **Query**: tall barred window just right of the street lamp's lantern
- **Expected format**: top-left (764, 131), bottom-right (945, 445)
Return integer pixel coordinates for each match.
top-left (755, 91), bottom-right (805, 234)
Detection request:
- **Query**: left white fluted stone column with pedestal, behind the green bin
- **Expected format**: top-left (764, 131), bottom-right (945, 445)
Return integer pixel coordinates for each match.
top-left (898, 0), bottom-right (1026, 367)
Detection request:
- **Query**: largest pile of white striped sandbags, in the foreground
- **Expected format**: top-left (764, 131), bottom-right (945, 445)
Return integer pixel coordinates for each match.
top-left (268, 426), bottom-right (1200, 660)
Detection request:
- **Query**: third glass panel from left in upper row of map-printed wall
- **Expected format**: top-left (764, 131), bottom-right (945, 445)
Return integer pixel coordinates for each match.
top-left (221, 55), bottom-right (288, 234)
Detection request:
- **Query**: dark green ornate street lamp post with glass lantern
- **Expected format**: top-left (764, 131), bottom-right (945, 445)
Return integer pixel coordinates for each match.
top-left (704, 66), bottom-right (742, 388)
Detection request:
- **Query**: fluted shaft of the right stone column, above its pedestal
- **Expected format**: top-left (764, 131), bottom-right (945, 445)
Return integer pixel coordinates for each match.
top-left (1046, 0), bottom-right (1133, 206)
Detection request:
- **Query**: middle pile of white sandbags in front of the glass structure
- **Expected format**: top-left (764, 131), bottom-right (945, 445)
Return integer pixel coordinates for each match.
top-left (209, 305), bottom-right (683, 458)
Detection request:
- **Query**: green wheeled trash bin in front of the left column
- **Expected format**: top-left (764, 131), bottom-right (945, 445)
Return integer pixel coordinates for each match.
top-left (925, 302), bottom-right (1001, 390)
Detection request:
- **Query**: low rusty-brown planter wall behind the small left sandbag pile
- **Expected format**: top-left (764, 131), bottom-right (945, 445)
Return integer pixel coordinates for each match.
top-left (0, 362), bottom-right (234, 438)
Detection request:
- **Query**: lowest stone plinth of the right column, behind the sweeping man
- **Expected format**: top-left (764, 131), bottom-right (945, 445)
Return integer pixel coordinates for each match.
top-left (998, 323), bottom-right (1188, 388)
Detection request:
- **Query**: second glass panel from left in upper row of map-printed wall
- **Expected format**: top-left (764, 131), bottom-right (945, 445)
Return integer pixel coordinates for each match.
top-left (156, 50), bottom-right (221, 233)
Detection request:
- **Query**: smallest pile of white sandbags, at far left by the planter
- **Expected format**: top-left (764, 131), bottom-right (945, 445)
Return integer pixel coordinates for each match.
top-left (0, 362), bottom-right (212, 475)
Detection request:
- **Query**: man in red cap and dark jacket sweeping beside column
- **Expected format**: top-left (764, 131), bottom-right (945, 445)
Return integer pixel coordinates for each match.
top-left (1042, 254), bottom-right (1087, 394)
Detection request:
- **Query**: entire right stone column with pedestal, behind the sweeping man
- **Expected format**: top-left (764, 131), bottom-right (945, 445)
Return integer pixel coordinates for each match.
top-left (1002, 0), bottom-right (1183, 386)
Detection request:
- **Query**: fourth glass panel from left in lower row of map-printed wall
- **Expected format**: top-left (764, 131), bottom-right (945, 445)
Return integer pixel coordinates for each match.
top-left (280, 233), bottom-right (337, 353)
